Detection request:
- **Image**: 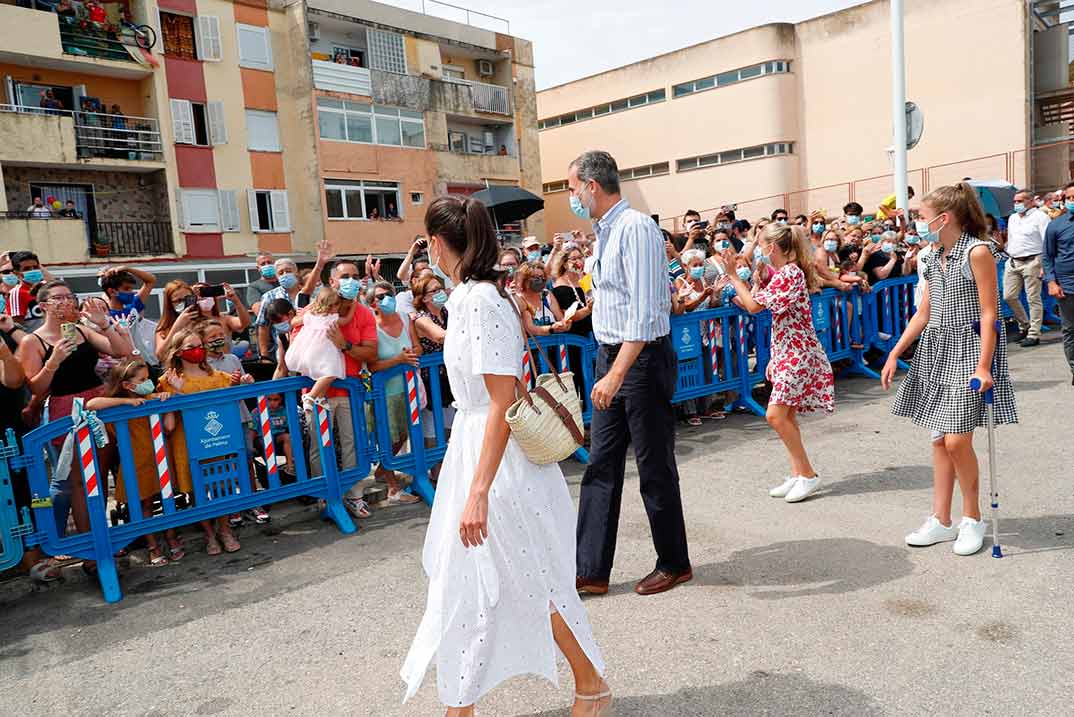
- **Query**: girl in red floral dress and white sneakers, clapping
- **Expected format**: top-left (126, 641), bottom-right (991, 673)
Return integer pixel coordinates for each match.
top-left (723, 223), bottom-right (836, 503)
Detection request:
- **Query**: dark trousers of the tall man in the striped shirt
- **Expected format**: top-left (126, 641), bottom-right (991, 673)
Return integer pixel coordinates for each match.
top-left (578, 336), bottom-right (690, 581)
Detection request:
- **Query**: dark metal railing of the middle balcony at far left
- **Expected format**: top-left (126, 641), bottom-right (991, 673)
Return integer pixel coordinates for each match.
top-left (0, 104), bottom-right (164, 161)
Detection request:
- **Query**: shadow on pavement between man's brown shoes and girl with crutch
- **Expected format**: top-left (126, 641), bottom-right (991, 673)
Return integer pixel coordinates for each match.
top-left (686, 538), bottom-right (914, 600)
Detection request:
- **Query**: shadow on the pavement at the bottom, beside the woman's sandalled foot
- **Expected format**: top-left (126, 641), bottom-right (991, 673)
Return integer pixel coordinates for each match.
top-left (519, 671), bottom-right (885, 717)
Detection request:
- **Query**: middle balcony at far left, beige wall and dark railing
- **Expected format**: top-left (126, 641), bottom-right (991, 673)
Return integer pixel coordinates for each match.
top-left (0, 104), bottom-right (164, 169)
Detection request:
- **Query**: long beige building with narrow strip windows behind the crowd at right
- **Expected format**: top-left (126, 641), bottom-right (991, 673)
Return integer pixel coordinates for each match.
top-left (537, 0), bottom-right (1056, 231)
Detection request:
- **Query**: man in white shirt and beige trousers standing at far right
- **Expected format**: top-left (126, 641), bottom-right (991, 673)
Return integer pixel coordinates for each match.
top-left (1003, 190), bottom-right (1049, 347)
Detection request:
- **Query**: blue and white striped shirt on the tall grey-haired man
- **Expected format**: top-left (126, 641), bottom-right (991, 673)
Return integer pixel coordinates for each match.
top-left (593, 194), bottom-right (671, 345)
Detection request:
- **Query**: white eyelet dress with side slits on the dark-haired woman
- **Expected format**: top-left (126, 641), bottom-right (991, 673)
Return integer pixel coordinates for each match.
top-left (400, 282), bottom-right (604, 706)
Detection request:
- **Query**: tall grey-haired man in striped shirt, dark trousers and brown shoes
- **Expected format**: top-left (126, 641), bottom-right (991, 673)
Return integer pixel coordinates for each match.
top-left (567, 151), bottom-right (693, 595)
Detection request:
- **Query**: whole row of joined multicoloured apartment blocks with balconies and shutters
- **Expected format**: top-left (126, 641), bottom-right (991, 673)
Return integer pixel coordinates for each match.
top-left (0, 0), bottom-right (541, 308)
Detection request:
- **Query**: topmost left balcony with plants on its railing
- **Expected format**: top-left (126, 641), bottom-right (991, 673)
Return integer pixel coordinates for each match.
top-left (0, 4), bottom-right (155, 79)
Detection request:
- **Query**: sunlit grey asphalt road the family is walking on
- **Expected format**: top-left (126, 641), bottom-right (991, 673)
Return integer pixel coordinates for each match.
top-left (0, 335), bottom-right (1074, 717)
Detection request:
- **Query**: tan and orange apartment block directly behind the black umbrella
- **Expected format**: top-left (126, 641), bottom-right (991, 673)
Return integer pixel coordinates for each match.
top-left (290, 0), bottom-right (543, 255)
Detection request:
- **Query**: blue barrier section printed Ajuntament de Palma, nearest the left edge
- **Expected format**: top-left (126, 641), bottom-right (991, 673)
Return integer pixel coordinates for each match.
top-left (17, 378), bottom-right (360, 602)
